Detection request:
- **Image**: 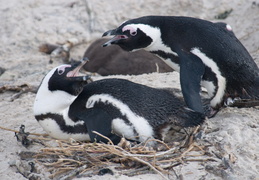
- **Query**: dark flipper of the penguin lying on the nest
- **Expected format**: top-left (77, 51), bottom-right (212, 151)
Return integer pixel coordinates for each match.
top-left (81, 107), bottom-right (121, 144)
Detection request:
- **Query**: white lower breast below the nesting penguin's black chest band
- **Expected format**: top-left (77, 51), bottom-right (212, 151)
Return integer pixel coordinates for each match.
top-left (39, 119), bottom-right (90, 141)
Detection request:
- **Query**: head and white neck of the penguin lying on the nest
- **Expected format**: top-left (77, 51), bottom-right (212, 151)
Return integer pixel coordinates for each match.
top-left (34, 59), bottom-right (90, 115)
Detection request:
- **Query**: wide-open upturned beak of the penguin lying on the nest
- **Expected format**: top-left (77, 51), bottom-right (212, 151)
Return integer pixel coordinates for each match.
top-left (67, 57), bottom-right (91, 81)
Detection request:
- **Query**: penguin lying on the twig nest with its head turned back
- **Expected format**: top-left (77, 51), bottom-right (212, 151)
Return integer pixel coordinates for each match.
top-left (33, 57), bottom-right (206, 144)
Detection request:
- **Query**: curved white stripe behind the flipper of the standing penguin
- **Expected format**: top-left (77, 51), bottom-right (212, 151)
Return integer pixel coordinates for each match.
top-left (191, 48), bottom-right (226, 107)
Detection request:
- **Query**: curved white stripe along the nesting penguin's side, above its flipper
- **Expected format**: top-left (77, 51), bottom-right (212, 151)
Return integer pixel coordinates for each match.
top-left (86, 94), bottom-right (154, 141)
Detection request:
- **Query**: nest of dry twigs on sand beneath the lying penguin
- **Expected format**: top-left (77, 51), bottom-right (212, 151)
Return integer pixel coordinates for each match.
top-left (10, 127), bottom-right (217, 179)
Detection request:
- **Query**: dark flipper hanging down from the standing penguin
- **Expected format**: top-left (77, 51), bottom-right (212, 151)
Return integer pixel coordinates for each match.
top-left (179, 52), bottom-right (205, 113)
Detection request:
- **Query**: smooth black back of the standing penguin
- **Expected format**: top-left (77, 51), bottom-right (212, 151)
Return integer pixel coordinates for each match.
top-left (119, 16), bottom-right (259, 98)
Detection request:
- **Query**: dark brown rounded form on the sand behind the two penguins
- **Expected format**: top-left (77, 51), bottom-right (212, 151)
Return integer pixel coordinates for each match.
top-left (83, 38), bottom-right (173, 76)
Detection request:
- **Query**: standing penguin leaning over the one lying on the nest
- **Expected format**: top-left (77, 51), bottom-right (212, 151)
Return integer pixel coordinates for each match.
top-left (103, 16), bottom-right (259, 117)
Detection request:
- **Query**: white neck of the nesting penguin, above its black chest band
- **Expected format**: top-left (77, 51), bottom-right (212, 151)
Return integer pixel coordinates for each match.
top-left (34, 87), bottom-right (77, 115)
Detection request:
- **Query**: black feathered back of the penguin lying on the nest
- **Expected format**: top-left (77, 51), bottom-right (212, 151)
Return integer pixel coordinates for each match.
top-left (70, 79), bottom-right (204, 127)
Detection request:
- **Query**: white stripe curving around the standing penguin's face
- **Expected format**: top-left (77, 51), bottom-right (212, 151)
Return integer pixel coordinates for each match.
top-left (127, 24), bottom-right (178, 56)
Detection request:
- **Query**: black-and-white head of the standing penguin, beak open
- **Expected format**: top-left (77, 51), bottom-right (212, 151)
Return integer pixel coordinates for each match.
top-left (103, 16), bottom-right (161, 51)
